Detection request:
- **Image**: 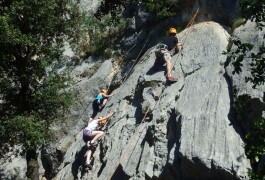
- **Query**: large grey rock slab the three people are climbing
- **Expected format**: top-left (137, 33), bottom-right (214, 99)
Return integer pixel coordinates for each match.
top-left (54, 22), bottom-right (250, 179)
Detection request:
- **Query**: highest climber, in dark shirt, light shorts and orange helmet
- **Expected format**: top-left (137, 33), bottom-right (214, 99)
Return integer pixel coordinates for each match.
top-left (154, 28), bottom-right (182, 82)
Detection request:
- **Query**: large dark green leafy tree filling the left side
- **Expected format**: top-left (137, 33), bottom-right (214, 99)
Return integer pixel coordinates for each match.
top-left (0, 0), bottom-right (80, 150)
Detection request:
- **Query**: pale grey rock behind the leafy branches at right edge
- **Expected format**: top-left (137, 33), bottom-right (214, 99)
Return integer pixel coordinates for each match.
top-left (226, 21), bottom-right (265, 132)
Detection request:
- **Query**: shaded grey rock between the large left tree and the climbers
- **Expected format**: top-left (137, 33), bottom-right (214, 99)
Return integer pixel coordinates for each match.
top-left (38, 57), bottom-right (114, 178)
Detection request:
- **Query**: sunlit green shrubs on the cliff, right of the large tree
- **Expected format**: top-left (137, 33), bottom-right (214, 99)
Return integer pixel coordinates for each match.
top-left (76, 15), bottom-right (129, 57)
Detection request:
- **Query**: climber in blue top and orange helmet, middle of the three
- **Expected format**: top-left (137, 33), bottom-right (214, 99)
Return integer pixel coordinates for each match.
top-left (91, 89), bottom-right (114, 119)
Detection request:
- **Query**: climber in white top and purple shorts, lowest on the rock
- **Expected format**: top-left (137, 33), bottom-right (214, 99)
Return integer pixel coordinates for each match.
top-left (83, 111), bottom-right (116, 167)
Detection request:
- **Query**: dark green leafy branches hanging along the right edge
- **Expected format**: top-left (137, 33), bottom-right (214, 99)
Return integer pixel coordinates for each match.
top-left (225, 0), bottom-right (265, 179)
